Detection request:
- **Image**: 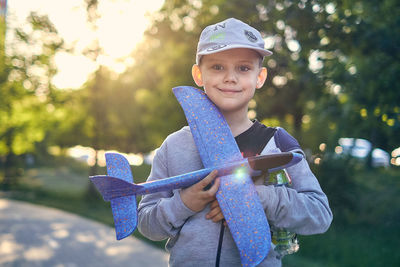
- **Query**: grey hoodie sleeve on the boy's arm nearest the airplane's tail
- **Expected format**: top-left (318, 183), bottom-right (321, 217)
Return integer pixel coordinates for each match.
top-left (138, 142), bottom-right (195, 241)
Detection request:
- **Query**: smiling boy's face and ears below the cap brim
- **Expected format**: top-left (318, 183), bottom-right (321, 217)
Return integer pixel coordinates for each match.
top-left (192, 48), bottom-right (267, 114)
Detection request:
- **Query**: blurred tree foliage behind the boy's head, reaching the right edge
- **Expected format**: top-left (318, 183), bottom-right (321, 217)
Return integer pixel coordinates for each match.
top-left (114, 0), bottom-right (400, 157)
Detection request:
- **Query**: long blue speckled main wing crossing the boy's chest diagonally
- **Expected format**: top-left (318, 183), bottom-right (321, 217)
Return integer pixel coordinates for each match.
top-left (173, 86), bottom-right (271, 266)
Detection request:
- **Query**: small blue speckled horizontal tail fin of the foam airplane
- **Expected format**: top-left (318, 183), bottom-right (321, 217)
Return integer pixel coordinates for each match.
top-left (106, 153), bottom-right (137, 240)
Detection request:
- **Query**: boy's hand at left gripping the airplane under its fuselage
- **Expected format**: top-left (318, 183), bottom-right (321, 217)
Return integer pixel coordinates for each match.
top-left (180, 170), bottom-right (219, 212)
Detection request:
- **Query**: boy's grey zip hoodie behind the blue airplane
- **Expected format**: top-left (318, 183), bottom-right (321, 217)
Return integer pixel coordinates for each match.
top-left (138, 126), bottom-right (332, 267)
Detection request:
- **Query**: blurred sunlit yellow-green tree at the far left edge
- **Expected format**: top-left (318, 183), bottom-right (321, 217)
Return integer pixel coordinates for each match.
top-left (0, 13), bottom-right (63, 186)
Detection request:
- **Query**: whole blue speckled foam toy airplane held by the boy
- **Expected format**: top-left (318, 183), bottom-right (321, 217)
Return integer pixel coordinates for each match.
top-left (90, 86), bottom-right (303, 266)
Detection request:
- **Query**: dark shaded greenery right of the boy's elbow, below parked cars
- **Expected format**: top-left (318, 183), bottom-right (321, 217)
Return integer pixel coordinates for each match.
top-left (283, 159), bottom-right (400, 266)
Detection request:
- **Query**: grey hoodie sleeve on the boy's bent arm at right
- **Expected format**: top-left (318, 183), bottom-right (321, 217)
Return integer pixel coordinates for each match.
top-left (256, 131), bottom-right (333, 235)
